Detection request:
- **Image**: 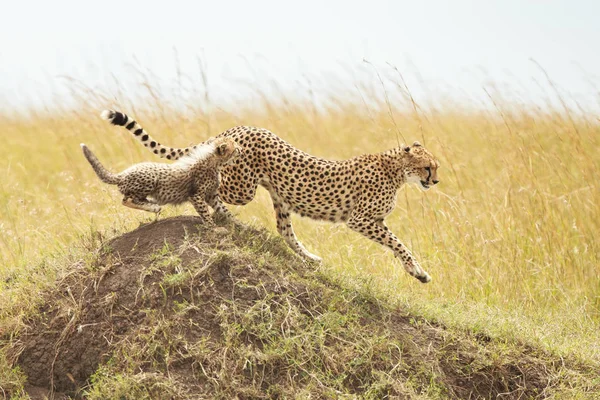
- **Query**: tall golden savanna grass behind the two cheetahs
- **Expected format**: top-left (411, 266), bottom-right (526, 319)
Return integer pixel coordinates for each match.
top-left (0, 72), bottom-right (600, 396)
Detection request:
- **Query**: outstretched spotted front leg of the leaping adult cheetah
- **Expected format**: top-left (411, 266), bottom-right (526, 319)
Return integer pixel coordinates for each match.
top-left (347, 215), bottom-right (431, 283)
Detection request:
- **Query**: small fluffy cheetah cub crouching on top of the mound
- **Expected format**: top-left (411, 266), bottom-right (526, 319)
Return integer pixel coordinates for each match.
top-left (81, 138), bottom-right (240, 225)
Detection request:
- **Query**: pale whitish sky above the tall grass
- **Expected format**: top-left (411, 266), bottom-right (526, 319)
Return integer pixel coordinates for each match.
top-left (0, 0), bottom-right (600, 110)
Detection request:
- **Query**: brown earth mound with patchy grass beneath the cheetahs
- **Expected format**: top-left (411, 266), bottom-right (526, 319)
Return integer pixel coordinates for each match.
top-left (11, 217), bottom-right (588, 399)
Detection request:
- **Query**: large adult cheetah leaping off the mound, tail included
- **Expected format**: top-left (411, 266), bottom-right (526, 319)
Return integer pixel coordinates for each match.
top-left (103, 111), bottom-right (439, 283)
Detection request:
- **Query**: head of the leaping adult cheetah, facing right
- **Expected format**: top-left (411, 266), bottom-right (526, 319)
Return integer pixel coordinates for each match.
top-left (402, 142), bottom-right (440, 190)
